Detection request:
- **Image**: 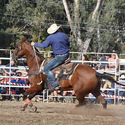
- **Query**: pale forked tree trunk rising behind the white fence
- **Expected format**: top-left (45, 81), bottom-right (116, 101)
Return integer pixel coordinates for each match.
top-left (63, 0), bottom-right (104, 54)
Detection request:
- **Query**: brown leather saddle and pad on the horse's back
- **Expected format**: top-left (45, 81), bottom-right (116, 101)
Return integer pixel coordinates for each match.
top-left (40, 57), bottom-right (77, 79)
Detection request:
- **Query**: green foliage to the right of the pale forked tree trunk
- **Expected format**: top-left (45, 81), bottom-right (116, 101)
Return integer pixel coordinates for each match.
top-left (89, 0), bottom-right (125, 53)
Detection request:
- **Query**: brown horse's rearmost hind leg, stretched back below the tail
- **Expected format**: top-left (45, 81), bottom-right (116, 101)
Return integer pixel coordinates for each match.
top-left (92, 90), bottom-right (107, 109)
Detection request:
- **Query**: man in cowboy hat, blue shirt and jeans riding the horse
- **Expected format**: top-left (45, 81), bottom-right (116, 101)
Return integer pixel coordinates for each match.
top-left (31, 24), bottom-right (70, 92)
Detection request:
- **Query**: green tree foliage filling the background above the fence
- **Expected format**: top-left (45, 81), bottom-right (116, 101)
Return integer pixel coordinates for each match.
top-left (0, 0), bottom-right (125, 52)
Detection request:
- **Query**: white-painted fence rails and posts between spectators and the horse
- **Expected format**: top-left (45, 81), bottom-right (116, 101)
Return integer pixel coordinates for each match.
top-left (0, 49), bottom-right (125, 103)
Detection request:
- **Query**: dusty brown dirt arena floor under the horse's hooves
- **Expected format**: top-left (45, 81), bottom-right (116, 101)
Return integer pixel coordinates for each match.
top-left (0, 101), bottom-right (125, 125)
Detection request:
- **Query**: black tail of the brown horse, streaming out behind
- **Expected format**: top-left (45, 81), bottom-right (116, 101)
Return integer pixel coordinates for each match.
top-left (96, 72), bottom-right (125, 86)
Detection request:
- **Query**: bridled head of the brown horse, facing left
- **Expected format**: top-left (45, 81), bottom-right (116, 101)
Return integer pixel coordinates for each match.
top-left (12, 37), bottom-right (27, 62)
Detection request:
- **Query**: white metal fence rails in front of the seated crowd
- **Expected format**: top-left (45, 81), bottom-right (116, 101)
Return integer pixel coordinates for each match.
top-left (0, 49), bottom-right (125, 103)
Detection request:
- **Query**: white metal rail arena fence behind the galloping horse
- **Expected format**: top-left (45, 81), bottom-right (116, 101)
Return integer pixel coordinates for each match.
top-left (0, 49), bottom-right (125, 103)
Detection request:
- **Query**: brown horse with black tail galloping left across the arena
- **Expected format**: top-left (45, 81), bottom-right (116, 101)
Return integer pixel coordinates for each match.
top-left (12, 37), bottom-right (124, 111)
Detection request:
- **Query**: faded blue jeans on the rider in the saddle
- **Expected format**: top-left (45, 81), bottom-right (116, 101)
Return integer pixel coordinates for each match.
top-left (44, 53), bottom-right (69, 88)
